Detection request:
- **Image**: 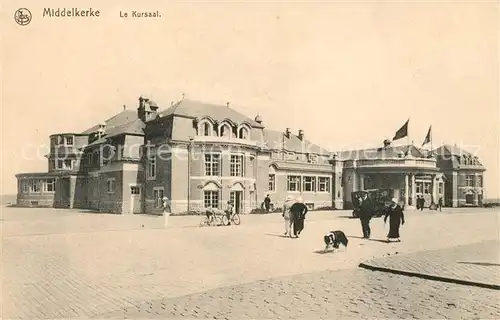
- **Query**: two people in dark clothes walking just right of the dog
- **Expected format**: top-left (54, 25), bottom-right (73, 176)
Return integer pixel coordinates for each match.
top-left (359, 194), bottom-right (405, 242)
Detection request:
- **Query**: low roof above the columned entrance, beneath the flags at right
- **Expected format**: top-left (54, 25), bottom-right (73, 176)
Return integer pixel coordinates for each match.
top-left (336, 145), bottom-right (425, 160)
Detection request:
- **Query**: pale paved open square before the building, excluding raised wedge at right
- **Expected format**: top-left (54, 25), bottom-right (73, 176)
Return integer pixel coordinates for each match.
top-left (1, 208), bottom-right (499, 319)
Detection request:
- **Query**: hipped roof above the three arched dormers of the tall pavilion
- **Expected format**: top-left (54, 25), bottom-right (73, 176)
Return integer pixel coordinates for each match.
top-left (159, 99), bottom-right (263, 128)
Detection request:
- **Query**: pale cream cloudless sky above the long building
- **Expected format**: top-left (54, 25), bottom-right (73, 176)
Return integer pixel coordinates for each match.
top-left (0, 0), bottom-right (500, 198)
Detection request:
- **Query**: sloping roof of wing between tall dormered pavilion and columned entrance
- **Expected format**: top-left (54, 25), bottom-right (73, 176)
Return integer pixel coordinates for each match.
top-left (264, 129), bottom-right (331, 156)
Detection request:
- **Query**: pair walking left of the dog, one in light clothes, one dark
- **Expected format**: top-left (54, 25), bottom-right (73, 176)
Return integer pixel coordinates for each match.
top-left (282, 196), bottom-right (308, 238)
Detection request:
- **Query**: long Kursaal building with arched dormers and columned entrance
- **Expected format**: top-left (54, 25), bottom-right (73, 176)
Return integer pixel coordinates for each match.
top-left (16, 97), bottom-right (485, 214)
